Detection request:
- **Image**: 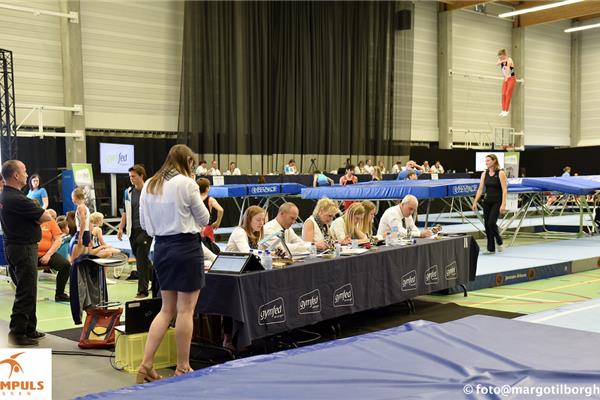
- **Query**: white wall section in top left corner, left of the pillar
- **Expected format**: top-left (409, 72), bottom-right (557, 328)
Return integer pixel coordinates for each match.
top-left (0, 0), bottom-right (64, 127)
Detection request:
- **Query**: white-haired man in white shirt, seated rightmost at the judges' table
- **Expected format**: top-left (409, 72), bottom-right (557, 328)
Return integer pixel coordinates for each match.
top-left (377, 194), bottom-right (433, 238)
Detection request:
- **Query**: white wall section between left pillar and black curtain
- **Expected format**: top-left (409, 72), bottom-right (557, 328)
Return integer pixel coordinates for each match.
top-left (81, 1), bottom-right (184, 131)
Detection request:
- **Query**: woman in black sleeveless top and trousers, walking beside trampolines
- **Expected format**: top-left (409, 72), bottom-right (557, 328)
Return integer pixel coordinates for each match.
top-left (473, 154), bottom-right (508, 254)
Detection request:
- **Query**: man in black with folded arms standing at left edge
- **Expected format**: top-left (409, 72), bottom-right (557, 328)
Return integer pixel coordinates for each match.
top-left (0, 160), bottom-right (51, 346)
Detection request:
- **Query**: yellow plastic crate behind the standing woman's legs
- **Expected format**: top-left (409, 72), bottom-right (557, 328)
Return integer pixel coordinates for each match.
top-left (115, 328), bottom-right (177, 372)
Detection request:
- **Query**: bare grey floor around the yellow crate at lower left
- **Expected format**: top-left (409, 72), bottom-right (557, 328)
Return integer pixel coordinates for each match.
top-left (0, 321), bottom-right (173, 400)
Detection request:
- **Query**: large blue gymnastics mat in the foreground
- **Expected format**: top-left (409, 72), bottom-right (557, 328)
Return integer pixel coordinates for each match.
top-left (84, 315), bottom-right (600, 400)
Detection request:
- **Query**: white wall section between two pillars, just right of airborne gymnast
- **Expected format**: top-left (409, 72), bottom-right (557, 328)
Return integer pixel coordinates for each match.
top-left (517, 21), bottom-right (571, 146)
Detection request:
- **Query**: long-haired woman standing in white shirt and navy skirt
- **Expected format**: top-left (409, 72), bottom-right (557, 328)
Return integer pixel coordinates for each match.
top-left (136, 144), bottom-right (209, 383)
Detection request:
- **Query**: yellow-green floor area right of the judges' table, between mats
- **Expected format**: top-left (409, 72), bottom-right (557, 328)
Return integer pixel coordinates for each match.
top-left (419, 269), bottom-right (600, 314)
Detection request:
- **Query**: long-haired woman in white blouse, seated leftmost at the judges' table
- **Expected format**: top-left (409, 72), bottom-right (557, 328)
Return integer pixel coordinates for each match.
top-left (225, 206), bottom-right (267, 253)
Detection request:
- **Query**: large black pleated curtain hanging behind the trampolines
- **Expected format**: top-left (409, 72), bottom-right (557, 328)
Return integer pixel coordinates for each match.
top-left (179, 1), bottom-right (398, 161)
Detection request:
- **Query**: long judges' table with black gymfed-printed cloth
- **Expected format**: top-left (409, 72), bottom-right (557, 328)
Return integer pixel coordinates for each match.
top-left (197, 236), bottom-right (479, 347)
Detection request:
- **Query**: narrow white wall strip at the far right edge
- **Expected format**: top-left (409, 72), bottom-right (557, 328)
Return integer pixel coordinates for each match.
top-left (579, 19), bottom-right (600, 146)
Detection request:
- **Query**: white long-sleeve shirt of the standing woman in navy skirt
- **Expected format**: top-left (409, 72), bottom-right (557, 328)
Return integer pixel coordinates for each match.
top-left (140, 175), bottom-right (209, 236)
